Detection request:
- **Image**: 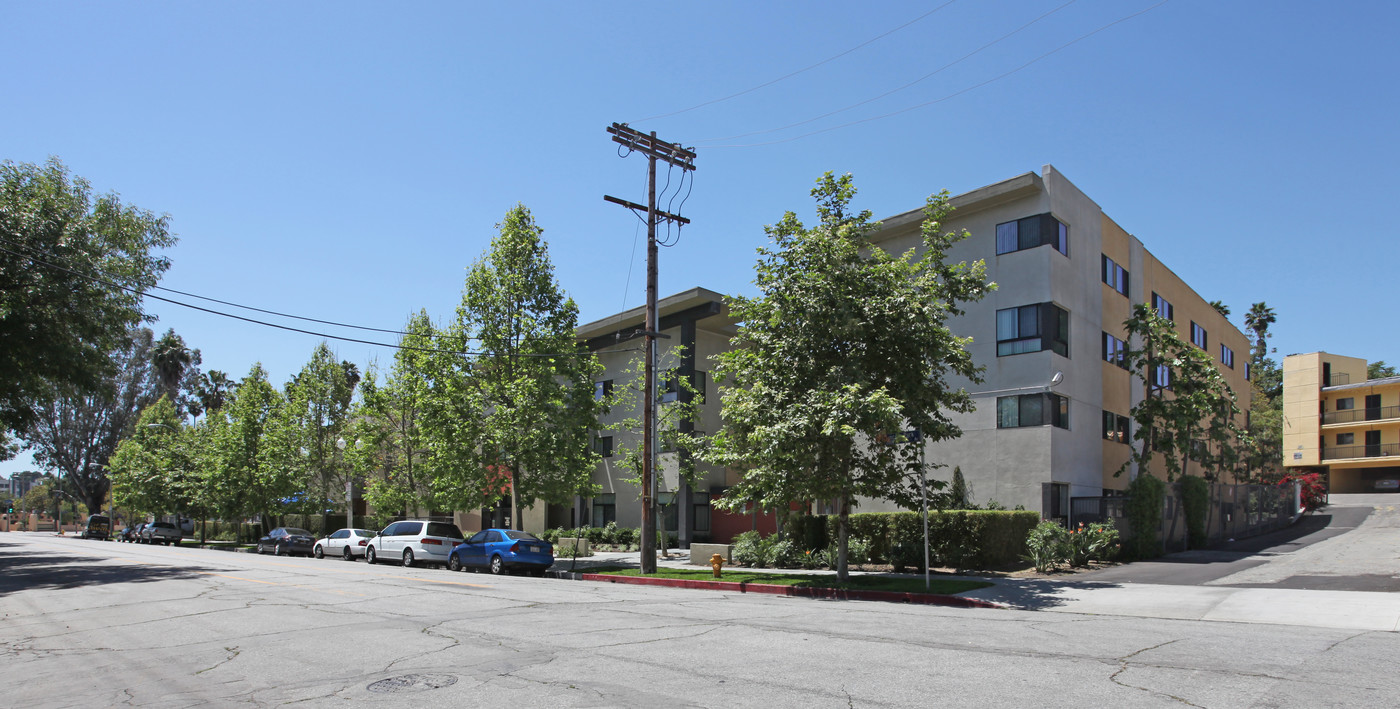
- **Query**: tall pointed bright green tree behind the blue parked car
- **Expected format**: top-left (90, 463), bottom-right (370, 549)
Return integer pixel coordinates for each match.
top-left (455, 205), bottom-right (602, 528)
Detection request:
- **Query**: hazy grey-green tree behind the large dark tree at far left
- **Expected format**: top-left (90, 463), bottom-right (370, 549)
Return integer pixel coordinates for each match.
top-left (27, 328), bottom-right (157, 510)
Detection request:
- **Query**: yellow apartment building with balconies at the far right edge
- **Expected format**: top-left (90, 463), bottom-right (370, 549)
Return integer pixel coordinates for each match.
top-left (1284, 352), bottom-right (1400, 492)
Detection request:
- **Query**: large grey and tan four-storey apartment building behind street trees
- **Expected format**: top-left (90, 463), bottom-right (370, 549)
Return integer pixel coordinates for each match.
top-left (574, 165), bottom-right (1250, 541)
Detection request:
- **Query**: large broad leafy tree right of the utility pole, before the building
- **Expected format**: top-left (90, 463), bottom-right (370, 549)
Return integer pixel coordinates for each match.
top-left (707, 172), bottom-right (994, 579)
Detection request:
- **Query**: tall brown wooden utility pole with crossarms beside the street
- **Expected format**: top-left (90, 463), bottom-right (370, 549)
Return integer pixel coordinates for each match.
top-left (603, 123), bottom-right (696, 573)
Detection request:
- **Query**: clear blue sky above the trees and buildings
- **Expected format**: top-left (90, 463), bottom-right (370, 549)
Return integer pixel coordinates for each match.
top-left (0, 0), bottom-right (1400, 474)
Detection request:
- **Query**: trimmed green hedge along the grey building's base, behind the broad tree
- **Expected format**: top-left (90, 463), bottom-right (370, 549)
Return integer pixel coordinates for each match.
top-left (788, 510), bottom-right (1040, 570)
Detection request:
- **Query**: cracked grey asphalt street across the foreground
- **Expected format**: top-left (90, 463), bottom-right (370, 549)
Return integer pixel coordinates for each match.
top-left (8, 532), bottom-right (1400, 709)
